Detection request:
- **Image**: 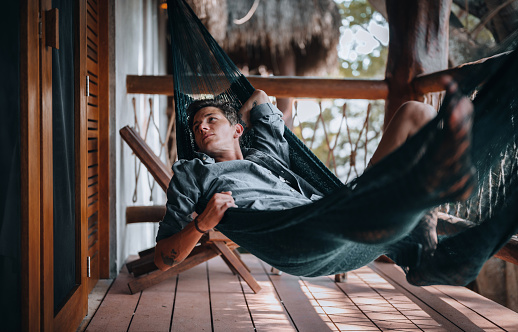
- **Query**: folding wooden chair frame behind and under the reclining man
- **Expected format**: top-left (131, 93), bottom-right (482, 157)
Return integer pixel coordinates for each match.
top-left (119, 126), bottom-right (261, 294)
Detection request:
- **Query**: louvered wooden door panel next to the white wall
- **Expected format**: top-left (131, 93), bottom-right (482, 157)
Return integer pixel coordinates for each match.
top-left (54, 0), bottom-right (109, 330)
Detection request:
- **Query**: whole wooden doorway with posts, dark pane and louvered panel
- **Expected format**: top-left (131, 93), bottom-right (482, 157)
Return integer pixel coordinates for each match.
top-left (20, 0), bottom-right (109, 331)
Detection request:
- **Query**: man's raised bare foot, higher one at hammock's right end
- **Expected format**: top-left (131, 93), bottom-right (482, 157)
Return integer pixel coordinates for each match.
top-left (426, 81), bottom-right (475, 201)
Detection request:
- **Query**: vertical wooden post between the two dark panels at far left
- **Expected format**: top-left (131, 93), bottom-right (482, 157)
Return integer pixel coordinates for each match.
top-left (20, 0), bottom-right (42, 331)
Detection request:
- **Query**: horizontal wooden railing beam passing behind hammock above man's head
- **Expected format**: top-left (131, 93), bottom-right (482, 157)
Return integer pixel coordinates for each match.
top-left (126, 75), bottom-right (388, 99)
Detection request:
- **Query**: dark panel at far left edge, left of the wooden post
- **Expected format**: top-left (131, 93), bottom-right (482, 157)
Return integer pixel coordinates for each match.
top-left (0, 1), bottom-right (21, 331)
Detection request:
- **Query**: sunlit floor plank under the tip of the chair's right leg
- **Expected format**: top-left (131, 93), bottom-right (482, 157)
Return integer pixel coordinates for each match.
top-left (241, 255), bottom-right (296, 332)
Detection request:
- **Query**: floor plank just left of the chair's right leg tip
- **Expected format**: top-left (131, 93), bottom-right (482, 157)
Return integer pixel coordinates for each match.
top-left (207, 258), bottom-right (254, 332)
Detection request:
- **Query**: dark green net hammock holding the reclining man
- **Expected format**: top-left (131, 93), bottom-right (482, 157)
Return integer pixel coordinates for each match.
top-left (168, 0), bottom-right (518, 284)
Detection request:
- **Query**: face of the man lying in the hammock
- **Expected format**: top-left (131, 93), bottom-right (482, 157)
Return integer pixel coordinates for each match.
top-left (192, 106), bottom-right (241, 157)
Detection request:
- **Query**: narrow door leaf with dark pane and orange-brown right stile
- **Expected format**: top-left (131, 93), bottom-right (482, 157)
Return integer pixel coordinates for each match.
top-left (50, 0), bottom-right (88, 331)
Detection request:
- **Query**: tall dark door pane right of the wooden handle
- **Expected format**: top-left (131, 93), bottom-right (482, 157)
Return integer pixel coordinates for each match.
top-left (52, 0), bottom-right (77, 311)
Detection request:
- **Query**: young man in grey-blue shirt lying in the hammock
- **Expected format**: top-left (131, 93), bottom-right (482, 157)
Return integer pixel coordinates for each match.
top-left (155, 76), bottom-right (510, 282)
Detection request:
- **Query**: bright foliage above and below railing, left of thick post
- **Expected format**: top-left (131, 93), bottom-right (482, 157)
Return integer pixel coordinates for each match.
top-left (294, 0), bottom-right (388, 182)
